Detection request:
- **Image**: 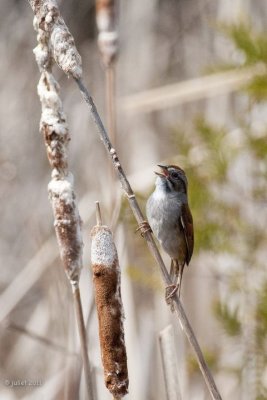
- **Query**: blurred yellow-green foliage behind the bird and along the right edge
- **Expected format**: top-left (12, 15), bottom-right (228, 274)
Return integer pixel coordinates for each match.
top-left (174, 19), bottom-right (267, 400)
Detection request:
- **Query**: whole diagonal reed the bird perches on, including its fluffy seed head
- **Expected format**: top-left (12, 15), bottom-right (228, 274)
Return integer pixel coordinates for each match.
top-left (29, 0), bottom-right (221, 400)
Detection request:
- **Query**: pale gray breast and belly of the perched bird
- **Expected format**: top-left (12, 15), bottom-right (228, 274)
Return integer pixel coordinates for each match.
top-left (146, 188), bottom-right (184, 259)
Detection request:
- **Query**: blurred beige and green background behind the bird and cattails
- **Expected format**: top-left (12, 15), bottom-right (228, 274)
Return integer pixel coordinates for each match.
top-left (0, 0), bottom-right (267, 400)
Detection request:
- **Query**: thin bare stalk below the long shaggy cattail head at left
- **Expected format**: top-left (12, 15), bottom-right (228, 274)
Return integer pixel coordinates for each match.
top-left (72, 283), bottom-right (94, 400)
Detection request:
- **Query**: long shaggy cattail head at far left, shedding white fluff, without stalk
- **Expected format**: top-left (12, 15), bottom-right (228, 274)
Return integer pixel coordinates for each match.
top-left (31, 0), bottom-right (83, 283)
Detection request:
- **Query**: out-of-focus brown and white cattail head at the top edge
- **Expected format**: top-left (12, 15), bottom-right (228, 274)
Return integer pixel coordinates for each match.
top-left (96, 0), bottom-right (118, 66)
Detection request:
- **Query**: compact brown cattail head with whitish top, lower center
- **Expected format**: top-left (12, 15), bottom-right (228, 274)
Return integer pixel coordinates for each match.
top-left (91, 203), bottom-right (129, 399)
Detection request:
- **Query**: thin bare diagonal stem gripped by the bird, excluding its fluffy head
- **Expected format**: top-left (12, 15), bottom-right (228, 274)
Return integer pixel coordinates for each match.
top-left (74, 77), bottom-right (221, 400)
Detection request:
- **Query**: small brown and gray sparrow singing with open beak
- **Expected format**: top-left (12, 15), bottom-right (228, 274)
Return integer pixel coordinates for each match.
top-left (146, 165), bottom-right (194, 301)
